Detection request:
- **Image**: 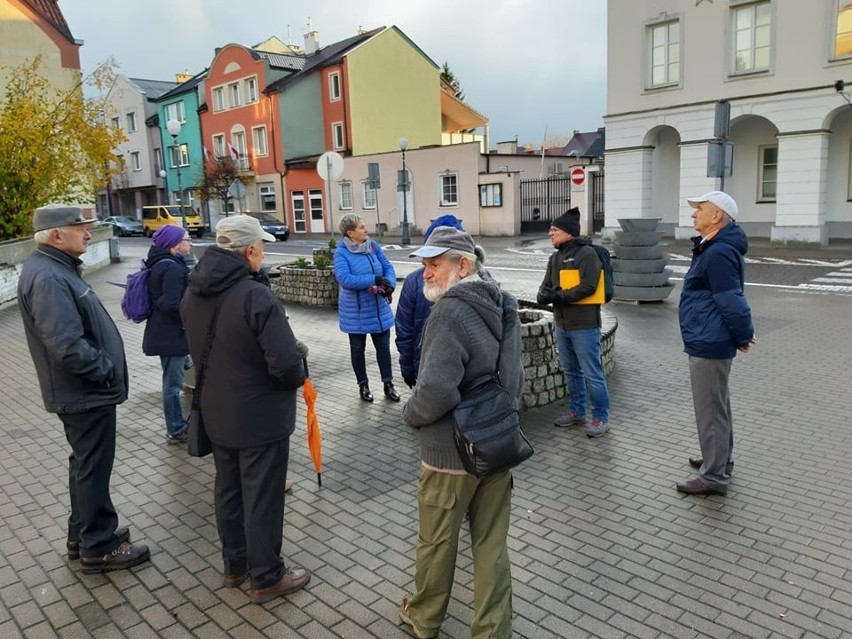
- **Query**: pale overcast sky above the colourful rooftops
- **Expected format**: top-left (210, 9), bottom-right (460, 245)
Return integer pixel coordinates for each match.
top-left (59, 0), bottom-right (606, 145)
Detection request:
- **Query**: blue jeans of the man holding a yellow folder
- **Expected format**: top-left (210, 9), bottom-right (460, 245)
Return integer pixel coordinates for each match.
top-left (554, 326), bottom-right (609, 422)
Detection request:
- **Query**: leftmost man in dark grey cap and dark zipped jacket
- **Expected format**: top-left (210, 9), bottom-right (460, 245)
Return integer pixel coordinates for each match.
top-left (18, 205), bottom-right (150, 573)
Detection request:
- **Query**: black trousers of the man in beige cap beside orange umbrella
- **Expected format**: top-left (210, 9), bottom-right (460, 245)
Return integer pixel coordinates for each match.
top-left (213, 437), bottom-right (290, 588)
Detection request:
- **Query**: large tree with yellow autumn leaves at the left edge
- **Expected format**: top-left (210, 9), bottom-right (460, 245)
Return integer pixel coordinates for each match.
top-left (0, 56), bottom-right (124, 239)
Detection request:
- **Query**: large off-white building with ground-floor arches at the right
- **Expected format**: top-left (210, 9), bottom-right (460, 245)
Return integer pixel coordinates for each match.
top-left (605, 0), bottom-right (852, 245)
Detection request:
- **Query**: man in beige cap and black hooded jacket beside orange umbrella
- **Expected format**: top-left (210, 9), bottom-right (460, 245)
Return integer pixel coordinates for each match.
top-left (181, 215), bottom-right (310, 603)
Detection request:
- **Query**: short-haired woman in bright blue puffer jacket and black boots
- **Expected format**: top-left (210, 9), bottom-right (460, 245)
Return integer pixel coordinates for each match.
top-left (334, 213), bottom-right (399, 402)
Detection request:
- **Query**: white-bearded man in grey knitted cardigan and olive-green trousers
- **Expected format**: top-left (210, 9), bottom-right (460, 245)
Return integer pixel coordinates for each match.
top-left (400, 226), bottom-right (523, 637)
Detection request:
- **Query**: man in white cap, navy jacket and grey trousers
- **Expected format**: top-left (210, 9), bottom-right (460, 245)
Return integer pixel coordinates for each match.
top-left (677, 191), bottom-right (755, 495)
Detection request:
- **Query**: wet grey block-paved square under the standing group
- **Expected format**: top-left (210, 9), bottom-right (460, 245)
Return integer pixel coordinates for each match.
top-left (0, 242), bottom-right (852, 639)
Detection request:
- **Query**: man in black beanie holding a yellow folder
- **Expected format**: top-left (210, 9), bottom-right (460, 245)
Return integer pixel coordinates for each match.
top-left (537, 207), bottom-right (609, 437)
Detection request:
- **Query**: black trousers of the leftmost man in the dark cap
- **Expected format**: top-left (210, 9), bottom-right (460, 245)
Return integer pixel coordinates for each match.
top-left (59, 405), bottom-right (119, 557)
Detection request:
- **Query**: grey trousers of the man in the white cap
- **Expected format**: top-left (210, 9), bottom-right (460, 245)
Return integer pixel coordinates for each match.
top-left (689, 355), bottom-right (734, 490)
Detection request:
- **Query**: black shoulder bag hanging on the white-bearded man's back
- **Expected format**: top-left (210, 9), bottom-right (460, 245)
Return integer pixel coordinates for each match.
top-left (451, 311), bottom-right (533, 477)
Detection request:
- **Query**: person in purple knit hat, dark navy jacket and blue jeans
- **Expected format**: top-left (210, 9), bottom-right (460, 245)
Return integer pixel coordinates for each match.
top-left (142, 224), bottom-right (192, 444)
